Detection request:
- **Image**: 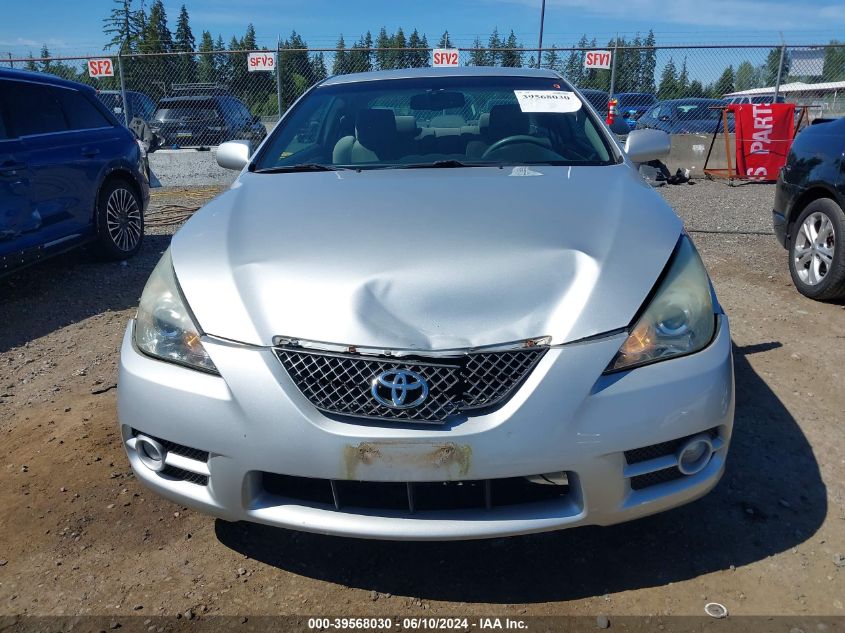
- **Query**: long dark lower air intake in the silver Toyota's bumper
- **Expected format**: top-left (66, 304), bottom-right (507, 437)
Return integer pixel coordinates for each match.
top-left (262, 473), bottom-right (569, 513)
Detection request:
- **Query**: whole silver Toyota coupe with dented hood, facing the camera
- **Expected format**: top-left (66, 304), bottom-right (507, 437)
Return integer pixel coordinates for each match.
top-left (118, 68), bottom-right (734, 540)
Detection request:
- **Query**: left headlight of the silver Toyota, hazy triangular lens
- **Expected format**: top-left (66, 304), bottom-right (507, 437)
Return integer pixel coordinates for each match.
top-left (135, 249), bottom-right (217, 374)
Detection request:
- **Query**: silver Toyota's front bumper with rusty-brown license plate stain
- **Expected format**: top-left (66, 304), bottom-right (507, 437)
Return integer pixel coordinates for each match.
top-left (118, 315), bottom-right (734, 540)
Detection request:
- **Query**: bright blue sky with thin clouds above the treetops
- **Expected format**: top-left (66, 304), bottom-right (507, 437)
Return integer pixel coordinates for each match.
top-left (0, 0), bottom-right (845, 58)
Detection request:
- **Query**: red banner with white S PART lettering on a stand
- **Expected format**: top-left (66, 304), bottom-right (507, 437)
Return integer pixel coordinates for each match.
top-left (728, 103), bottom-right (795, 181)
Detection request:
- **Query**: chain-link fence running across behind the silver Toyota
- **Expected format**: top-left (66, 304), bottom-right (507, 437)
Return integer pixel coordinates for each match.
top-left (6, 45), bottom-right (845, 146)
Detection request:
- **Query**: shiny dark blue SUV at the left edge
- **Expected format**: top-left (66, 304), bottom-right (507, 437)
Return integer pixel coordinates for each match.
top-left (0, 69), bottom-right (149, 275)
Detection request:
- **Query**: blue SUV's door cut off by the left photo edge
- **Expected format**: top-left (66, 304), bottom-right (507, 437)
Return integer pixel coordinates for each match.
top-left (0, 79), bottom-right (41, 260)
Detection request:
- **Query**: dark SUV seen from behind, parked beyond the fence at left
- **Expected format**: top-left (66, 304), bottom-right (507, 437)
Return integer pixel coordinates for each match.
top-left (150, 95), bottom-right (267, 147)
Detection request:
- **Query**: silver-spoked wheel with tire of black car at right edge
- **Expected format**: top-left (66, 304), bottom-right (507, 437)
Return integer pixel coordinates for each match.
top-left (789, 198), bottom-right (845, 301)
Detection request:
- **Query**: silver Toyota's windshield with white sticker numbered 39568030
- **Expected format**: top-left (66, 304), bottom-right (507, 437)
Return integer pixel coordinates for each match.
top-left (250, 76), bottom-right (615, 171)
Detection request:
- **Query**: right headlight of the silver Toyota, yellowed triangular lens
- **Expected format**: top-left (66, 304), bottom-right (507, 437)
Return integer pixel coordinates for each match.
top-left (605, 236), bottom-right (716, 372)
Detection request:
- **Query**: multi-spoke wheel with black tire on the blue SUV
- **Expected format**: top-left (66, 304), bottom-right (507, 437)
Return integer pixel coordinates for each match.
top-left (96, 178), bottom-right (144, 261)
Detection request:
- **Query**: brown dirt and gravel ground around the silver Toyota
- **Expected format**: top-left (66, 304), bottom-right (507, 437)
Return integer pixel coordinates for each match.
top-left (0, 182), bottom-right (845, 630)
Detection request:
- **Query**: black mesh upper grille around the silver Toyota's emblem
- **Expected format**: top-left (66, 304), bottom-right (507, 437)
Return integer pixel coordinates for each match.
top-left (276, 346), bottom-right (548, 423)
